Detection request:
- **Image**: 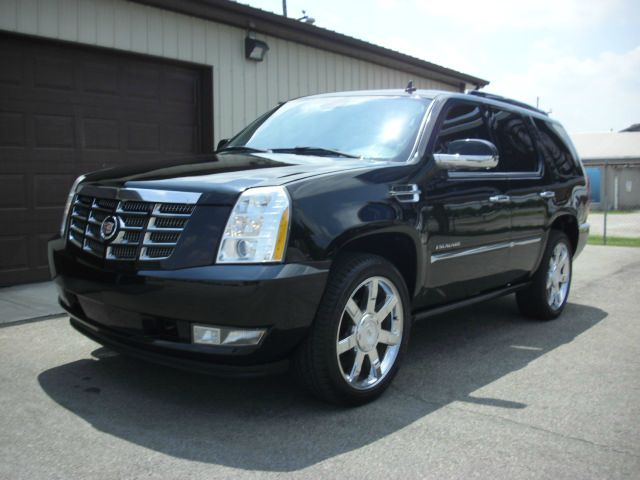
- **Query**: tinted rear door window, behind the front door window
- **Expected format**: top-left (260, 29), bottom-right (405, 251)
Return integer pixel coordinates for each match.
top-left (489, 107), bottom-right (538, 172)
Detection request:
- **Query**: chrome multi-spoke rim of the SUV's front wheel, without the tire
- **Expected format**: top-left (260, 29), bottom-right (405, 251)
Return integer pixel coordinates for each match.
top-left (336, 277), bottom-right (404, 390)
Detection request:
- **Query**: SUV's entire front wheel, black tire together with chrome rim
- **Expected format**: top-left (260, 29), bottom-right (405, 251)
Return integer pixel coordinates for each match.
top-left (292, 254), bottom-right (411, 406)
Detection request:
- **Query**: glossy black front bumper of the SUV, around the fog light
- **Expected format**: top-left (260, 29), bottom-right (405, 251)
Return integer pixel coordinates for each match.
top-left (49, 240), bottom-right (328, 375)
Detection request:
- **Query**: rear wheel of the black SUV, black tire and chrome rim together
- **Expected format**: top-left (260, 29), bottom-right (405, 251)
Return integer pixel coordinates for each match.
top-left (516, 230), bottom-right (573, 320)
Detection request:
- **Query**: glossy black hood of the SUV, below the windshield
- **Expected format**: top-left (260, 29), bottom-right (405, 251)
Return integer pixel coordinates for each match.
top-left (78, 153), bottom-right (386, 205)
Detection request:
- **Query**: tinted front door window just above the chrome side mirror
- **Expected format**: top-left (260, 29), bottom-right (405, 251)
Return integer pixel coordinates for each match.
top-left (433, 103), bottom-right (492, 153)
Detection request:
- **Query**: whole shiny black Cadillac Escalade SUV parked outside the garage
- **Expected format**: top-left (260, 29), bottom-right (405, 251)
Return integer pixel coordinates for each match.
top-left (49, 88), bottom-right (589, 404)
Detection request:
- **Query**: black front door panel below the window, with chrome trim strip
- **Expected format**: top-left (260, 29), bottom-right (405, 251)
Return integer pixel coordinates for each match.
top-left (425, 173), bottom-right (510, 306)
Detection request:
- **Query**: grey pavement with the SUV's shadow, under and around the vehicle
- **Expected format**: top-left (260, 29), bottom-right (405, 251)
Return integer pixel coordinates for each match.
top-left (0, 246), bottom-right (640, 479)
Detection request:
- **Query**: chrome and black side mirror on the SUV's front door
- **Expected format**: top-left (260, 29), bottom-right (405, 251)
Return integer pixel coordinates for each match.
top-left (433, 138), bottom-right (498, 170)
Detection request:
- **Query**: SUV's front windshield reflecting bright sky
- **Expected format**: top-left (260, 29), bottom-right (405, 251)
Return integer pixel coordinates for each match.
top-left (225, 96), bottom-right (429, 161)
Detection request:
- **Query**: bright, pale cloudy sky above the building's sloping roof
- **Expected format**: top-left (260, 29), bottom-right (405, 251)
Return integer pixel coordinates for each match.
top-left (242, 0), bottom-right (640, 133)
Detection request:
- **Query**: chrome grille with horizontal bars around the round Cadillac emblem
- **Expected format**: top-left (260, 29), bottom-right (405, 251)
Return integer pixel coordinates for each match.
top-left (67, 195), bottom-right (195, 261)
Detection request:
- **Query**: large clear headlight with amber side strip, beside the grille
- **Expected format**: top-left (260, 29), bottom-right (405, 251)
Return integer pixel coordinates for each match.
top-left (218, 187), bottom-right (290, 263)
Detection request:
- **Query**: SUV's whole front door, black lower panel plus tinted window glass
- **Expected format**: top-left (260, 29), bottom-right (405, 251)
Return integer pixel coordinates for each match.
top-left (421, 100), bottom-right (510, 306)
